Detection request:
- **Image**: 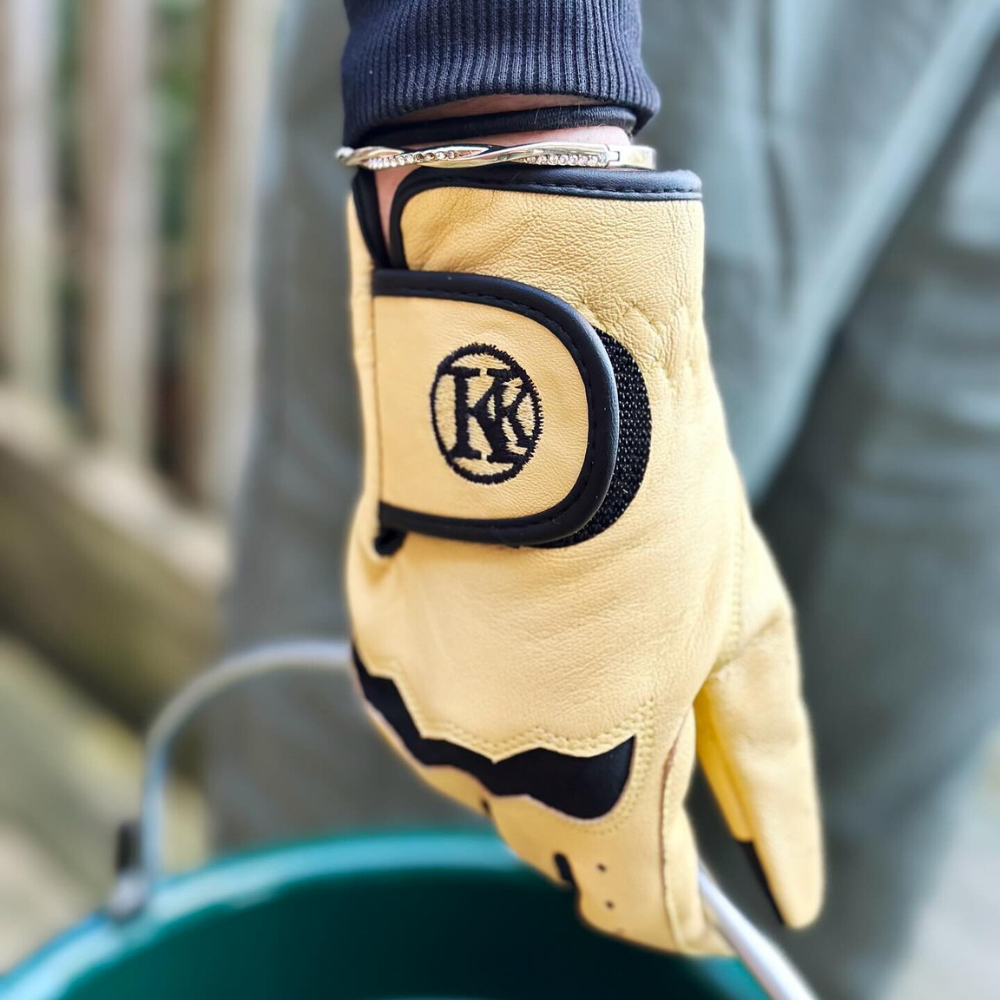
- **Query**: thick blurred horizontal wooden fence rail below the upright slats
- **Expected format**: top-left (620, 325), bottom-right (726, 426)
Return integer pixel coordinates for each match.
top-left (0, 388), bottom-right (227, 723)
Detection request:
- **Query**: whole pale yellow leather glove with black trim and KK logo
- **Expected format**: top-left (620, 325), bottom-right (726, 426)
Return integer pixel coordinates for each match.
top-left (348, 167), bottom-right (823, 952)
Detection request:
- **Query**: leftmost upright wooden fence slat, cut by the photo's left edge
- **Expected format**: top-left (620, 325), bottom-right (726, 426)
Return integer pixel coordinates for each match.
top-left (0, 0), bottom-right (57, 396)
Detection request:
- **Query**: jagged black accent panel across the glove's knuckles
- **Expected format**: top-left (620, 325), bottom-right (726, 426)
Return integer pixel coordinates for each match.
top-left (354, 650), bottom-right (635, 819)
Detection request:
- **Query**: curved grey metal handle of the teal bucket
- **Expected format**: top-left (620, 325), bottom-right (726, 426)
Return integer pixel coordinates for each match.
top-left (108, 639), bottom-right (816, 1000)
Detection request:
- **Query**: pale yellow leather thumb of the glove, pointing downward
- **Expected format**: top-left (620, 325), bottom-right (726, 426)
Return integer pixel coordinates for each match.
top-left (696, 608), bottom-right (823, 927)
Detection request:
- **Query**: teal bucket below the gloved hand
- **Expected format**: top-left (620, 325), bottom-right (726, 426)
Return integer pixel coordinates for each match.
top-left (0, 831), bottom-right (764, 1000)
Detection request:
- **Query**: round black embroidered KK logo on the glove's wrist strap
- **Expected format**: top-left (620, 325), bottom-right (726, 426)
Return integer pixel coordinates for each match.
top-left (431, 344), bottom-right (542, 483)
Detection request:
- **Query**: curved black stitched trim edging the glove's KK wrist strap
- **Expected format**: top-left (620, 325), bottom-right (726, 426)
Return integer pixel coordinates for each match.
top-left (372, 270), bottom-right (618, 545)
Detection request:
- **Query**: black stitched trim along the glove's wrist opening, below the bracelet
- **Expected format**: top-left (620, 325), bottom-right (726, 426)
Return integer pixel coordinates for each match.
top-left (389, 164), bottom-right (701, 268)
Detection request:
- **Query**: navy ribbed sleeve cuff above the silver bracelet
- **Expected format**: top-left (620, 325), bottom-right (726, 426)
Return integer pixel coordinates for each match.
top-left (342, 0), bottom-right (659, 145)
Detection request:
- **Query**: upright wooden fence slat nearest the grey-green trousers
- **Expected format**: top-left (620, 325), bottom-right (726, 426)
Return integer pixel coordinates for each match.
top-left (185, 0), bottom-right (278, 509)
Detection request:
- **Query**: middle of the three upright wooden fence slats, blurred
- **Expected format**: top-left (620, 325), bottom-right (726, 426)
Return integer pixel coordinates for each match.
top-left (80, 0), bottom-right (155, 460)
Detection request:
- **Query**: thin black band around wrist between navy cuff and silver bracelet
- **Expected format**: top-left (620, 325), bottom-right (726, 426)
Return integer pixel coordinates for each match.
top-left (357, 104), bottom-right (635, 146)
